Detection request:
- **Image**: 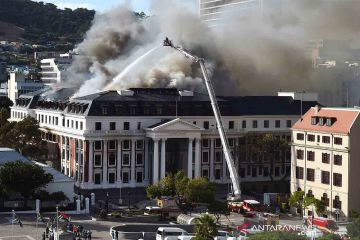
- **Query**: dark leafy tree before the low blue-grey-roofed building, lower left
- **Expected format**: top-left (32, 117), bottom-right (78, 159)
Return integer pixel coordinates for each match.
top-left (0, 161), bottom-right (53, 204)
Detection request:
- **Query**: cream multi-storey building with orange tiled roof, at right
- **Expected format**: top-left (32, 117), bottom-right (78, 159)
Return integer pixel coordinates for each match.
top-left (291, 107), bottom-right (360, 217)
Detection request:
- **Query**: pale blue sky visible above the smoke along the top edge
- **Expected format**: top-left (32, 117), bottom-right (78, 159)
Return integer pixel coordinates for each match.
top-left (36, 0), bottom-right (198, 14)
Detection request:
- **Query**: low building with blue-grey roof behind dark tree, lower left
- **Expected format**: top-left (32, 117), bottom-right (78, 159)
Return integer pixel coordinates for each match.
top-left (0, 148), bottom-right (75, 200)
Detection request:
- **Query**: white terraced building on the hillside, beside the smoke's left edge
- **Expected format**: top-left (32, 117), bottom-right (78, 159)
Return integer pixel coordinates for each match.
top-left (41, 54), bottom-right (73, 85)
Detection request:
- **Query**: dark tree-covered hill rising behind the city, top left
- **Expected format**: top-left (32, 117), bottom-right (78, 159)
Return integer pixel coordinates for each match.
top-left (0, 0), bottom-right (95, 45)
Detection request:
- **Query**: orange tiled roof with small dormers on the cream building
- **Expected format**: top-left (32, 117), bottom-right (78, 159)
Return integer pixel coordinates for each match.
top-left (292, 107), bottom-right (360, 134)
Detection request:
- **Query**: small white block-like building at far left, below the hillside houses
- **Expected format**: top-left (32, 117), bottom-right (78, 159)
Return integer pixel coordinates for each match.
top-left (4, 72), bottom-right (45, 102)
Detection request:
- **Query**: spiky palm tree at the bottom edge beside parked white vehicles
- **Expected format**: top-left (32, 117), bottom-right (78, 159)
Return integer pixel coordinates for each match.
top-left (195, 214), bottom-right (218, 240)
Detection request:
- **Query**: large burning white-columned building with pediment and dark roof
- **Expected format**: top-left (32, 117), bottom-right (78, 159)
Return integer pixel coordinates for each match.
top-left (10, 88), bottom-right (316, 200)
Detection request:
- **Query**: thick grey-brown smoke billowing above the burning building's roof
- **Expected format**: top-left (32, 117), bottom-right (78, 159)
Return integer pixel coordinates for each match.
top-left (69, 0), bottom-right (360, 96)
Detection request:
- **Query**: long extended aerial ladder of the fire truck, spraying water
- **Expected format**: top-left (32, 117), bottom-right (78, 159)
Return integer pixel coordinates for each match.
top-left (163, 38), bottom-right (241, 199)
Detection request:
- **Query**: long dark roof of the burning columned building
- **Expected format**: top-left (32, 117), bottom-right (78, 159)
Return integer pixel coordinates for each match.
top-left (12, 88), bottom-right (318, 117)
